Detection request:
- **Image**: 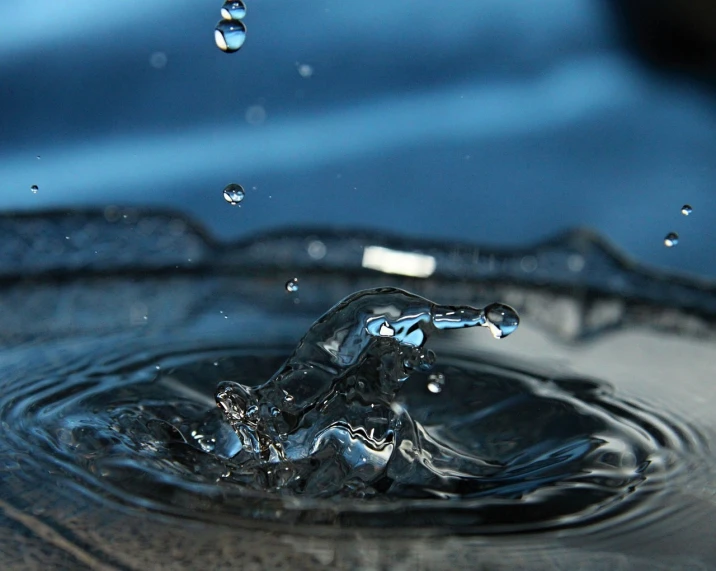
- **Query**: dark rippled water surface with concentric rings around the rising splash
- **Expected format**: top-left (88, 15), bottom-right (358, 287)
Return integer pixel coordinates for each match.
top-left (0, 211), bottom-right (716, 569)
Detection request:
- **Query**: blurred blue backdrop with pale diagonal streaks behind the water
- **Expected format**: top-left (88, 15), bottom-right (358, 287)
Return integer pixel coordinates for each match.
top-left (0, 0), bottom-right (716, 278)
